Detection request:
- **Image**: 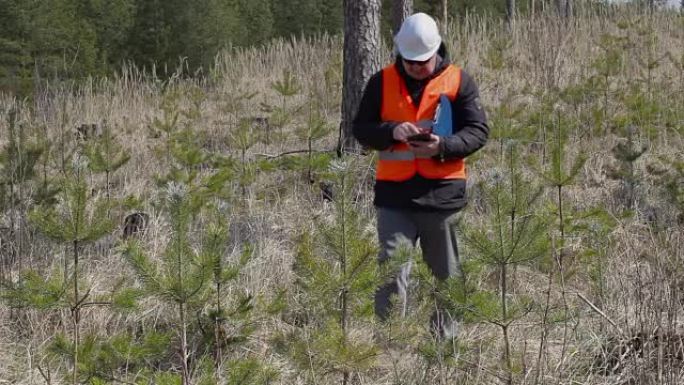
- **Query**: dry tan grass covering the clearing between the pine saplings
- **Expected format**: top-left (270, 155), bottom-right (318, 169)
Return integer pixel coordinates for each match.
top-left (0, 6), bottom-right (684, 385)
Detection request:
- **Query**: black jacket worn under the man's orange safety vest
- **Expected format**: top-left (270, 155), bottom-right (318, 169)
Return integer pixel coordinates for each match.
top-left (353, 45), bottom-right (489, 211)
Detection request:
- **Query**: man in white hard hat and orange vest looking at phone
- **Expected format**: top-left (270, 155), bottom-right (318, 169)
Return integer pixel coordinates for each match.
top-left (353, 13), bottom-right (489, 338)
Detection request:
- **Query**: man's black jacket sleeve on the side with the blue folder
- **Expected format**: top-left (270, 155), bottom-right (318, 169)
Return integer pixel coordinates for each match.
top-left (435, 70), bottom-right (489, 159)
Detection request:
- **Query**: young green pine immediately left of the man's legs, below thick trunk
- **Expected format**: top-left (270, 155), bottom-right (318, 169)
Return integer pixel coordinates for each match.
top-left (289, 159), bottom-right (379, 385)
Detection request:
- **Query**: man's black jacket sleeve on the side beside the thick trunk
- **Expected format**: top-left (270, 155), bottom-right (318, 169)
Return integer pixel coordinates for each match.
top-left (352, 72), bottom-right (399, 150)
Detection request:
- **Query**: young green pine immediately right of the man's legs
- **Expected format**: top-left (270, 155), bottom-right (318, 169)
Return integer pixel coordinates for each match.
top-left (450, 141), bottom-right (548, 384)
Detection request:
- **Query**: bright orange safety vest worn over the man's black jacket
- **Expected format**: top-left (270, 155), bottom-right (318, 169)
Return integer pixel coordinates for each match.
top-left (375, 64), bottom-right (466, 182)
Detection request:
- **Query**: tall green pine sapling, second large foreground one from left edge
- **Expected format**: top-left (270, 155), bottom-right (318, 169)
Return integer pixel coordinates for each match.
top-left (125, 164), bottom-right (239, 384)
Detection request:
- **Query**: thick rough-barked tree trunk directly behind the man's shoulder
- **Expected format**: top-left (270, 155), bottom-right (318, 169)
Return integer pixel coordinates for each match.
top-left (337, 0), bottom-right (380, 155)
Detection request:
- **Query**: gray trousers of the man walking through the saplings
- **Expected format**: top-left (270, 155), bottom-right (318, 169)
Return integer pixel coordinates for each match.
top-left (375, 207), bottom-right (460, 338)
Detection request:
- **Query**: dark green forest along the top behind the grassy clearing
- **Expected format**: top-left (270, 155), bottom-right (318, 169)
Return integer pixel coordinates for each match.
top-left (0, 0), bottom-right (680, 95)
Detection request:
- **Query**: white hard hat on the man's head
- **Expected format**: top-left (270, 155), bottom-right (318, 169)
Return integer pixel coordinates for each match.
top-left (394, 13), bottom-right (442, 61)
